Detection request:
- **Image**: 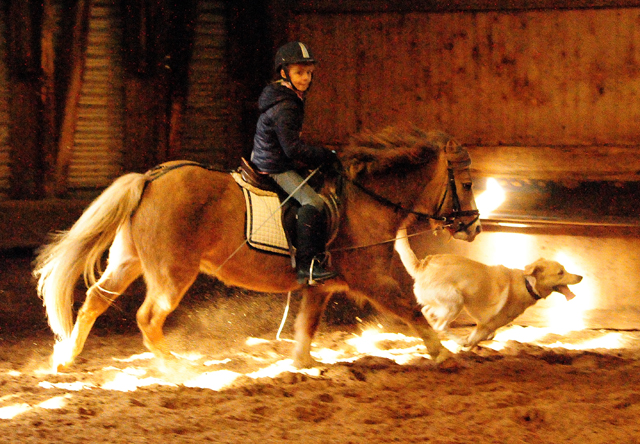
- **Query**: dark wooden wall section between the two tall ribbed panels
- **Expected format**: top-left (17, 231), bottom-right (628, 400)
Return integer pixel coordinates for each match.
top-left (123, 0), bottom-right (197, 171)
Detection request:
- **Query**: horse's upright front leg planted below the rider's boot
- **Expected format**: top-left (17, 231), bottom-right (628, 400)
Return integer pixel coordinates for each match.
top-left (293, 286), bottom-right (331, 368)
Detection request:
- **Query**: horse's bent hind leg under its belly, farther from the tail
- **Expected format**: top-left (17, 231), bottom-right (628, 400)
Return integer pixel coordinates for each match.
top-left (136, 264), bottom-right (199, 359)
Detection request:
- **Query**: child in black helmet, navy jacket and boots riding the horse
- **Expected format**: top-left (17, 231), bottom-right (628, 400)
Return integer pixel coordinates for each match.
top-left (251, 42), bottom-right (337, 285)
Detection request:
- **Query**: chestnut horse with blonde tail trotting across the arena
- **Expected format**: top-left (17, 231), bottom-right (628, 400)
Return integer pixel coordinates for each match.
top-left (33, 128), bottom-right (481, 371)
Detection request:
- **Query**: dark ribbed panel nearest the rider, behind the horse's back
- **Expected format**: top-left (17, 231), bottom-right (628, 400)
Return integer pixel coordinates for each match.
top-left (183, 0), bottom-right (239, 162)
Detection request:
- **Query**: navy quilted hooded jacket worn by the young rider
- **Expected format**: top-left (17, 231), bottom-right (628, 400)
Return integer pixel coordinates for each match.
top-left (251, 83), bottom-right (331, 173)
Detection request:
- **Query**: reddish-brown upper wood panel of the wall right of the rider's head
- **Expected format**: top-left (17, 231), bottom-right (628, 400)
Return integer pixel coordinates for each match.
top-left (291, 8), bottom-right (640, 145)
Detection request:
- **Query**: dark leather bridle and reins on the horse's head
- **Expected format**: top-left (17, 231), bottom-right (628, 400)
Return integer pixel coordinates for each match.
top-left (341, 161), bottom-right (480, 233)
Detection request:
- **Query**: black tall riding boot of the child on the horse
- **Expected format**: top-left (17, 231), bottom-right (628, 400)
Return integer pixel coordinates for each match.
top-left (296, 205), bottom-right (337, 285)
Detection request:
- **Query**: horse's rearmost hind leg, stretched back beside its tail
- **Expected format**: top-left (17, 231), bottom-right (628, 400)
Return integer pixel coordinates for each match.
top-left (53, 229), bottom-right (141, 370)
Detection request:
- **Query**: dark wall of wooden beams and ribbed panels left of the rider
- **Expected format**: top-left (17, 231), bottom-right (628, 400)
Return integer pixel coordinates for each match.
top-left (0, 0), bottom-right (255, 249)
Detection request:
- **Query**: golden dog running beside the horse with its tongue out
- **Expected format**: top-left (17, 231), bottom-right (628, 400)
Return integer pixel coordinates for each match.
top-left (395, 229), bottom-right (582, 349)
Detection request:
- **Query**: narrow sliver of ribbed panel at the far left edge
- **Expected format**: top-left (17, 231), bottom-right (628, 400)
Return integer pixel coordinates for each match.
top-left (0, 9), bottom-right (11, 199)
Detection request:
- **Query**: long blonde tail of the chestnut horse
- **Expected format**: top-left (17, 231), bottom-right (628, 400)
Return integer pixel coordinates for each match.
top-left (33, 173), bottom-right (147, 340)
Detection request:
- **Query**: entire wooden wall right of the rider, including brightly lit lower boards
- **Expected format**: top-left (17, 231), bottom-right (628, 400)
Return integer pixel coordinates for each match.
top-left (282, 0), bottom-right (640, 328)
